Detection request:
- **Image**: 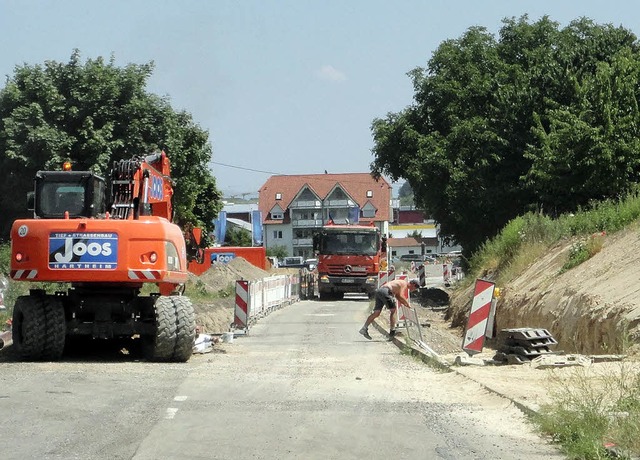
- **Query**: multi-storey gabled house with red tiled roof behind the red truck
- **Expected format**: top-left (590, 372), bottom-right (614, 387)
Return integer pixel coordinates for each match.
top-left (258, 173), bottom-right (392, 258)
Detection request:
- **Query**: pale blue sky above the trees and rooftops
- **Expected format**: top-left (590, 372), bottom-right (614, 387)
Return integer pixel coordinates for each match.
top-left (0, 0), bottom-right (640, 198)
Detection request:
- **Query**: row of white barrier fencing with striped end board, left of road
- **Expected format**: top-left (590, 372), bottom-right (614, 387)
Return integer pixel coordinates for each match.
top-left (231, 269), bottom-right (318, 333)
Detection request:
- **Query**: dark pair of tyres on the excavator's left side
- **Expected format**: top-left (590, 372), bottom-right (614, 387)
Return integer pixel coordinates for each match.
top-left (12, 296), bottom-right (66, 361)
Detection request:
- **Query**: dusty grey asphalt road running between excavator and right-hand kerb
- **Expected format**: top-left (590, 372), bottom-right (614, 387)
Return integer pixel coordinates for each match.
top-left (0, 298), bottom-right (561, 460)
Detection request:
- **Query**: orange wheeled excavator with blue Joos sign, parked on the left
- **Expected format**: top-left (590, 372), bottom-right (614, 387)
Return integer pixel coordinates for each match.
top-left (11, 151), bottom-right (201, 362)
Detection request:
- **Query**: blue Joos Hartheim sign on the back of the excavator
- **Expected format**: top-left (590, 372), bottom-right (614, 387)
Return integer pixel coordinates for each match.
top-left (49, 232), bottom-right (118, 270)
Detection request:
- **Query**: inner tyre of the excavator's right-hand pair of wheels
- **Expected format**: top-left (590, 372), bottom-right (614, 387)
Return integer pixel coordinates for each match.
top-left (143, 296), bottom-right (176, 361)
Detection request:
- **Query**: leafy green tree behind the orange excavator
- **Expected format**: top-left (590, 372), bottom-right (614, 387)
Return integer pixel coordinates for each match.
top-left (0, 50), bottom-right (222, 238)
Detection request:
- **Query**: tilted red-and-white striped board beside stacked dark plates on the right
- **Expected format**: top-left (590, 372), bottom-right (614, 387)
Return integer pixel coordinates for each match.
top-left (462, 279), bottom-right (496, 356)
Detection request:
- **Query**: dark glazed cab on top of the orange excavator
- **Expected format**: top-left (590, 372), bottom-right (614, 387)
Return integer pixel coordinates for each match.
top-left (27, 171), bottom-right (106, 219)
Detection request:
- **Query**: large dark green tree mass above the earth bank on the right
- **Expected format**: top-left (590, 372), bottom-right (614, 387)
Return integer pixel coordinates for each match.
top-left (371, 16), bottom-right (640, 252)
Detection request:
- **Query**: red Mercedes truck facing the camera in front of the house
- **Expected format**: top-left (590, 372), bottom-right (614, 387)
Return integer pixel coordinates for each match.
top-left (313, 223), bottom-right (387, 300)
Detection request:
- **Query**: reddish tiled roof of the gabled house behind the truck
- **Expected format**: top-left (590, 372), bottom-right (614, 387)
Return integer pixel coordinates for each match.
top-left (258, 173), bottom-right (391, 224)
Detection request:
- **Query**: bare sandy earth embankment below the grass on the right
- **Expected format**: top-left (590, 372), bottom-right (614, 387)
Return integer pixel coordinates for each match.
top-left (448, 226), bottom-right (640, 354)
